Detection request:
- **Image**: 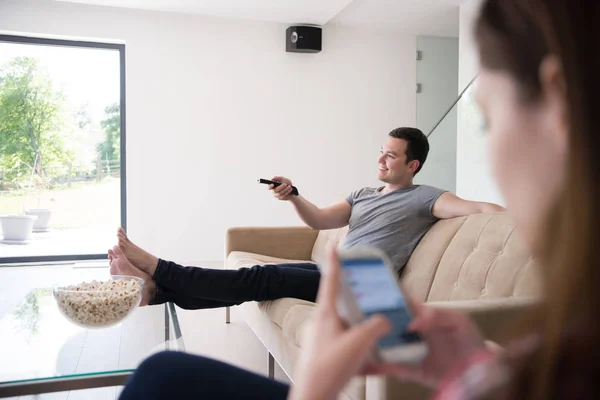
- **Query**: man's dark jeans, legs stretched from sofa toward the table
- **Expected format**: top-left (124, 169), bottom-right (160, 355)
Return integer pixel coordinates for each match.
top-left (150, 260), bottom-right (321, 310)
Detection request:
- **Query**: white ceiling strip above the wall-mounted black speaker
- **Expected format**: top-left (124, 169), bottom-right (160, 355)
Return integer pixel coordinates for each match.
top-left (57, 0), bottom-right (465, 36)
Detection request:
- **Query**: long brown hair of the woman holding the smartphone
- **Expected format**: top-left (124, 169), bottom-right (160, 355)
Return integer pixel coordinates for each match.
top-left (475, 0), bottom-right (600, 399)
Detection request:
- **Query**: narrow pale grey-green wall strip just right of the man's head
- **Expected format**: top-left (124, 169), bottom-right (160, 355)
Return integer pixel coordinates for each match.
top-left (415, 36), bottom-right (458, 193)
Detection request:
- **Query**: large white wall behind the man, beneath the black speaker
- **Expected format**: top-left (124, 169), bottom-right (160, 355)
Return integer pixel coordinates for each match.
top-left (0, 0), bottom-right (416, 262)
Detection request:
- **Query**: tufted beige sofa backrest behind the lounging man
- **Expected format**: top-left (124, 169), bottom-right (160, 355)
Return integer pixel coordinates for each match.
top-left (312, 213), bottom-right (539, 302)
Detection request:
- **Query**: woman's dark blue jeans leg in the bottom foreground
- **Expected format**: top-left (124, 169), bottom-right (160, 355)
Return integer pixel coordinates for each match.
top-left (119, 352), bottom-right (289, 400)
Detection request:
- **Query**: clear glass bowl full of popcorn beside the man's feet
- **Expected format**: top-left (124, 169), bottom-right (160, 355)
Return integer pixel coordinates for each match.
top-left (53, 275), bottom-right (144, 328)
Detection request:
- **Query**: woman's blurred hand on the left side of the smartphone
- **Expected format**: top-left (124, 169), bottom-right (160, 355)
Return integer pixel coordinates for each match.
top-left (289, 251), bottom-right (393, 400)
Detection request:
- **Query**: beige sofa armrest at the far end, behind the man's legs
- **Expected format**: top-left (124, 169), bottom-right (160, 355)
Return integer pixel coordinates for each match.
top-left (225, 227), bottom-right (319, 260)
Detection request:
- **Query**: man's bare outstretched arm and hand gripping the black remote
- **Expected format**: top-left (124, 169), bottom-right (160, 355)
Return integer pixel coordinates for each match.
top-left (269, 176), bottom-right (352, 230)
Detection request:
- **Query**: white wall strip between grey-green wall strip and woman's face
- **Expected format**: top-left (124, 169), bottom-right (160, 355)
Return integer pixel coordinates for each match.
top-left (456, 0), bottom-right (504, 204)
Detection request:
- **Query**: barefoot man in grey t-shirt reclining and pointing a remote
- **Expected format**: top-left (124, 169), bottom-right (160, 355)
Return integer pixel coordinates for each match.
top-left (108, 128), bottom-right (504, 309)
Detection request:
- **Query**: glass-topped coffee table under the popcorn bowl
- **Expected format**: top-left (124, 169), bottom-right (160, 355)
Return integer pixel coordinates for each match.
top-left (0, 266), bottom-right (185, 399)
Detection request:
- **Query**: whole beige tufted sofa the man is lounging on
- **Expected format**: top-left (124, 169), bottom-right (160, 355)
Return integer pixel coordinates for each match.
top-left (225, 213), bottom-right (539, 400)
